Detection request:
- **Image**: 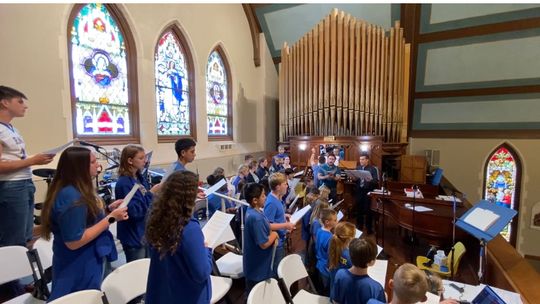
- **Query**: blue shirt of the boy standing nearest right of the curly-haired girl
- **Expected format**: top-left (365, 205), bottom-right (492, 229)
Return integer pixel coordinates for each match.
top-left (243, 207), bottom-right (273, 282)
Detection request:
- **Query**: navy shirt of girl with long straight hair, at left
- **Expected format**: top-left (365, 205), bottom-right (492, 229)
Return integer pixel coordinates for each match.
top-left (48, 186), bottom-right (117, 301)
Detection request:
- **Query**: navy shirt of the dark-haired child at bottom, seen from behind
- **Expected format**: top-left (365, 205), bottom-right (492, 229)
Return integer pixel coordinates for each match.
top-left (332, 269), bottom-right (386, 304)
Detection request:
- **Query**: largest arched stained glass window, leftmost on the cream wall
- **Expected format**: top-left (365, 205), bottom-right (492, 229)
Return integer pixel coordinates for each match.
top-left (68, 3), bottom-right (139, 143)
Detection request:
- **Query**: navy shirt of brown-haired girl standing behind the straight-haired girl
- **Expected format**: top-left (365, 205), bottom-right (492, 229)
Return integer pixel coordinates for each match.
top-left (114, 174), bottom-right (153, 248)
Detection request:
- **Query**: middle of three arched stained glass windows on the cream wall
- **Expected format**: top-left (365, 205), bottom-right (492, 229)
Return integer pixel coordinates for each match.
top-left (154, 26), bottom-right (196, 142)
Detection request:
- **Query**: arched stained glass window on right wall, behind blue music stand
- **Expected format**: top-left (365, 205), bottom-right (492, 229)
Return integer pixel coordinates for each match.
top-left (484, 144), bottom-right (521, 245)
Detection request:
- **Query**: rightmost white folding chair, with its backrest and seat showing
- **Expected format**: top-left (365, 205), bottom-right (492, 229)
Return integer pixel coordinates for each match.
top-left (278, 254), bottom-right (330, 303)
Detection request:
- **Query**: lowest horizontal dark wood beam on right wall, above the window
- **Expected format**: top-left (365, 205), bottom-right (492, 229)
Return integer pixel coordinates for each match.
top-left (410, 130), bottom-right (540, 139)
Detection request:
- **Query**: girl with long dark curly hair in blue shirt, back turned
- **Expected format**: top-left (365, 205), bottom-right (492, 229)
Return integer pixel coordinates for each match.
top-left (145, 171), bottom-right (212, 304)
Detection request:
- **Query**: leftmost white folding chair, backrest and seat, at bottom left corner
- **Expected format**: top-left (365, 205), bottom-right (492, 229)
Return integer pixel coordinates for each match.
top-left (0, 246), bottom-right (45, 304)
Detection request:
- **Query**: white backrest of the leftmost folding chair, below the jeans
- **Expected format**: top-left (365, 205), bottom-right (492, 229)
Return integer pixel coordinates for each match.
top-left (0, 246), bottom-right (32, 285)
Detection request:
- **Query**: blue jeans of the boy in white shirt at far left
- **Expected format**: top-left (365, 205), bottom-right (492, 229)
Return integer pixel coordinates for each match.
top-left (0, 179), bottom-right (36, 247)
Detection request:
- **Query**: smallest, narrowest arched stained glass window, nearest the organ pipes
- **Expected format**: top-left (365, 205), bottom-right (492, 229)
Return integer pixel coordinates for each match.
top-left (206, 47), bottom-right (232, 140)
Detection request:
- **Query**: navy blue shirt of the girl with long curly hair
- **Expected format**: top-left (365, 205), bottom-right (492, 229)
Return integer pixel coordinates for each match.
top-left (145, 218), bottom-right (212, 304)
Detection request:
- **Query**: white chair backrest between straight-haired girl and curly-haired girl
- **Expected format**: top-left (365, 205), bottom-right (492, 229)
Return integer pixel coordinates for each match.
top-left (101, 259), bottom-right (150, 304)
